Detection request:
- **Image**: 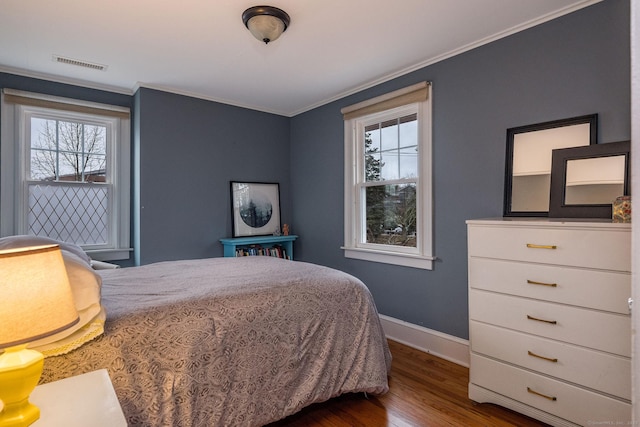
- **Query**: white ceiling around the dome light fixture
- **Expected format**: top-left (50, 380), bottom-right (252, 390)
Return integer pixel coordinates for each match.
top-left (0, 0), bottom-right (599, 116)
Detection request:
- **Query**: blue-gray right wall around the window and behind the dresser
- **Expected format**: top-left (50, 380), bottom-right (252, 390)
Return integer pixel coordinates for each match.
top-left (291, 0), bottom-right (630, 338)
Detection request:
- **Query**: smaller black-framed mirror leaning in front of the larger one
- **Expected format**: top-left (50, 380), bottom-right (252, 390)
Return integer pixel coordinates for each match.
top-left (549, 141), bottom-right (631, 218)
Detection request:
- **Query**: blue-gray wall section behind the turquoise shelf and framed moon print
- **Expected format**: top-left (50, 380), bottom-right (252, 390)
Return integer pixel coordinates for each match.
top-left (134, 89), bottom-right (292, 264)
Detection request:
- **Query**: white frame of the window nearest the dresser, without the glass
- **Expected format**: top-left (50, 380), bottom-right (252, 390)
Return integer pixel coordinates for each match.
top-left (342, 84), bottom-right (435, 270)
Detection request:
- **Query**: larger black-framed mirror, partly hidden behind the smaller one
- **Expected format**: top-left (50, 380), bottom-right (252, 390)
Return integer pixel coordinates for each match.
top-left (503, 114), bottom-right (598, 217)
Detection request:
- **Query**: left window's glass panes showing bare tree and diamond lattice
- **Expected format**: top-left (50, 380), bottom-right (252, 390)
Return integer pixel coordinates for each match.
top-left (27, 117), bottom-right (109, 245)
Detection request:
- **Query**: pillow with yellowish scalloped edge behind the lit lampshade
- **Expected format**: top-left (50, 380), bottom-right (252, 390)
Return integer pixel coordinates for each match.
top-left (0, 236), bottom-right (106, 357)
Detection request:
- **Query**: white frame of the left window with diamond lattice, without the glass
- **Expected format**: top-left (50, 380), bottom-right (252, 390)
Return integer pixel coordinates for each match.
top-left (0, 89), bottom-right (132, 261)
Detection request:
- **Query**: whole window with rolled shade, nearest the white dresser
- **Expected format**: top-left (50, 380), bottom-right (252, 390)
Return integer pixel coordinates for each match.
top-left (342, 82), bottom-right (433, 269)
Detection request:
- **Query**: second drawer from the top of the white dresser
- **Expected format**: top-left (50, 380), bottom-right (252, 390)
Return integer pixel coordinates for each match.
top-left (469, 257), bottom-right (631, 314)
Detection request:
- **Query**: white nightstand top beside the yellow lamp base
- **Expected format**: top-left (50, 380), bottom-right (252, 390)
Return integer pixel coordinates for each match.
top-left (29, 369), bottom-right (127, 427)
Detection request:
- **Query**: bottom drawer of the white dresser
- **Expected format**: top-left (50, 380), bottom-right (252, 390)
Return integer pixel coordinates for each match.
top-left (470, 354), bottom-right (631, 426)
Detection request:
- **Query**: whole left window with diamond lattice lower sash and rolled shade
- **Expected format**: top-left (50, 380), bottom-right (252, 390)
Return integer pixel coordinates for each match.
top-left (0, 89), bottom-right (130, 260)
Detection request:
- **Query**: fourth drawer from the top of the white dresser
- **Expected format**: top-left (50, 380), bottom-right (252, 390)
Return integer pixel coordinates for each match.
top-left (469, 321), bottom-right (631, 401)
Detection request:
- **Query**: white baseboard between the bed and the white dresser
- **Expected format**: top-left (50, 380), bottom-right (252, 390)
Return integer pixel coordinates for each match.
top-left (380, 314), bottom-right (469, 367)
